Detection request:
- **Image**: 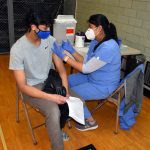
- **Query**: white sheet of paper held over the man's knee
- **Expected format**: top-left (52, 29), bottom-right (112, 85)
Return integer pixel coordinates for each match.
top-left (67, 96), bottom-right (85, 125)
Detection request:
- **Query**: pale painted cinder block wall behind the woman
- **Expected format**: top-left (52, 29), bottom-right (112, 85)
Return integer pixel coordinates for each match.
top-left (76, 0), bottom-right (150, 60)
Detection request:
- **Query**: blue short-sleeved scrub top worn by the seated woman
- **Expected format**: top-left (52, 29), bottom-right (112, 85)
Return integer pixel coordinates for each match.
top-left (85, 39), bottom-right (121, 93)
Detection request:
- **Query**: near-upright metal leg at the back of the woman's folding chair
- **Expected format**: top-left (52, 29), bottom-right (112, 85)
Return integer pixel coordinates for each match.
top-left (114, 93), bottom-right (121, 134)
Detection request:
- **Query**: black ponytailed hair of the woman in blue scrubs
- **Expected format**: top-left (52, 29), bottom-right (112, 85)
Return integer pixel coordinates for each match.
top-left (88, 14), bottom-right (118, 43)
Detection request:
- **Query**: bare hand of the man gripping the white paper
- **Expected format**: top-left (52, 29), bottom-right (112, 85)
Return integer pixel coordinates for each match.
top-left (48, 94), bottom-right (67, 104)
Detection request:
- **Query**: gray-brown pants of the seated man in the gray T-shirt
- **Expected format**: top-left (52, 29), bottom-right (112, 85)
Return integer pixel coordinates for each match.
top-left (23, 83), bottom-right (82, 150)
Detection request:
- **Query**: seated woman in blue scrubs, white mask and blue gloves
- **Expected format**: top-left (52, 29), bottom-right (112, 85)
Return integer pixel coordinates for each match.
top-left (53, 14), bottom-right (121, 131)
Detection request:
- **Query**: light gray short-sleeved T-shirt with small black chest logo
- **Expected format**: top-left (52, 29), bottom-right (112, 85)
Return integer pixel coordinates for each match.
top-left (9, 35), bottom-right (55, 86)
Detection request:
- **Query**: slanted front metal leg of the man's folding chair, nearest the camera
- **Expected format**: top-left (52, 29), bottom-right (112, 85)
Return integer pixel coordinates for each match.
top-left (23, 102), bottom-right (37, 145)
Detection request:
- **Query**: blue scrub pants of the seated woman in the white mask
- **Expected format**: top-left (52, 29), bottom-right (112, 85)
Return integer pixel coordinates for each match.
top-left (68, 73), bottom-right (109, 119)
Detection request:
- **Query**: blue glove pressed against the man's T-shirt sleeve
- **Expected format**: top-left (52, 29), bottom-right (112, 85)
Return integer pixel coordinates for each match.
top-left (52, 42), bottom-right (66, 60)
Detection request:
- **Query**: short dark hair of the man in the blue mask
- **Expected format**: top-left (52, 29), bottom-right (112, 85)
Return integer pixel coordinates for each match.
top-left (25, 7), bottom-right (53, 31)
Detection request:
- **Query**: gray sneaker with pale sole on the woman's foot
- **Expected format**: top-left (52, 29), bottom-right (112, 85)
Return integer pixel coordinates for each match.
top-left (76, 121), bottom-right (98, 131)
